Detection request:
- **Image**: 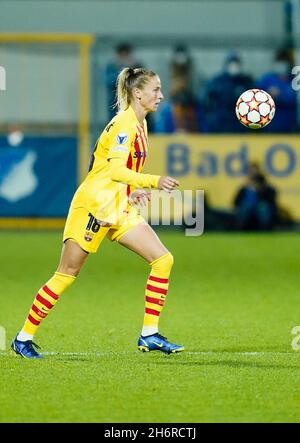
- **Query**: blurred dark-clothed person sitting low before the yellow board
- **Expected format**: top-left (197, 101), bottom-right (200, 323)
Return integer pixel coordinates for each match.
top-left (234, 171), bottom-right (278, 231)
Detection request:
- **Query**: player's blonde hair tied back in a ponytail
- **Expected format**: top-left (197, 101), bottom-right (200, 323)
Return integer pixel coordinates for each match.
top-left (115, 68), bottom-right (156, 111)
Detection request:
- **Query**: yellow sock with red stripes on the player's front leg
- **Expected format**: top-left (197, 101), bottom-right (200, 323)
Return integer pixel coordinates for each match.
top-left (142, 252), bottom-right (174, 337)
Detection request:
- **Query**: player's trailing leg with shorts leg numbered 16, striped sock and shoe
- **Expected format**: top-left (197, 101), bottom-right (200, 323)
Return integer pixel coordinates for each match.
top-left (11, 208), bottom-right (108, 358)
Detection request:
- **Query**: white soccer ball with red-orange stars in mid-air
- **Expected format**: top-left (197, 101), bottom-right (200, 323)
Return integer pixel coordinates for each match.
top-left (235, 89), bottom-right (275, 129)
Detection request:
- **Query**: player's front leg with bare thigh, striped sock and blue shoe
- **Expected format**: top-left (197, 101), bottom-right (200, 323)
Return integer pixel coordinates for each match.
top-left (118, 223), bottom-right (184, 354)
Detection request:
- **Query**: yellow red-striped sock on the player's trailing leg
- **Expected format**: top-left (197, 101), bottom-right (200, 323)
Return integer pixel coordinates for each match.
top-left (20, 272), bottom-right (76, 336)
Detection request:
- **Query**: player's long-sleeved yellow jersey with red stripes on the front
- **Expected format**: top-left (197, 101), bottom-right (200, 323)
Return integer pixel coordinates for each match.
top-left (72, 107), bottom-right (160, 224)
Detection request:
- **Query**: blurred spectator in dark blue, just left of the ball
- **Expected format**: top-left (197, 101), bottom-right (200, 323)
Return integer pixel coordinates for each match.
top-left (200, 52), bottom-right (253, 133)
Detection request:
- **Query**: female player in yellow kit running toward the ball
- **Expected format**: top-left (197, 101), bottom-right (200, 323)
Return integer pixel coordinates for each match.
top-left (11, 68), bottom-right (184, 358)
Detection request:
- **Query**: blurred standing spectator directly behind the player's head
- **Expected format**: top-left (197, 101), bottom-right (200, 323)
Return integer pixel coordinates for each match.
top-left (105, 43), bottom-right (143, 119)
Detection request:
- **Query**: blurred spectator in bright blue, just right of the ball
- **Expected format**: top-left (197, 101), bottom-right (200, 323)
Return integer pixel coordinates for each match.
top-left (257, 49), bottom-right (297, 132)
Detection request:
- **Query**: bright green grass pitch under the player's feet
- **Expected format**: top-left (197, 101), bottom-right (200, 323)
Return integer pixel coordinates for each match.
top-left (0, 232), bottom-right (300, 423)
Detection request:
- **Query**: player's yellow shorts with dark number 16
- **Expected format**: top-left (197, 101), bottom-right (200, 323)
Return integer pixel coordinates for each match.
top-left (63, 206), bottom-right (147, 252)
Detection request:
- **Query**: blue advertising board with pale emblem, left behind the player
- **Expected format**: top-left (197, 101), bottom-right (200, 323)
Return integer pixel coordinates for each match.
top-left (0, 136), bottom-right (77, 217)
